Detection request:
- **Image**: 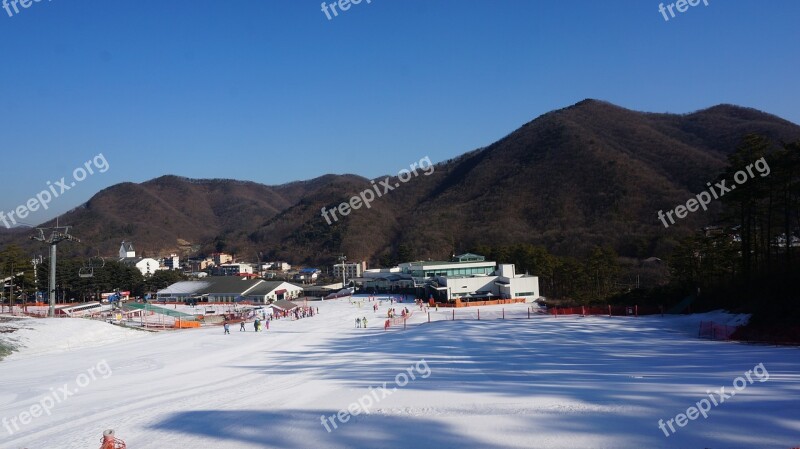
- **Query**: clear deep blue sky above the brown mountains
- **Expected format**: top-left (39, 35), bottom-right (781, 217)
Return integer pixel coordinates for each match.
top-left (0, 0), bottom-right (800, 224)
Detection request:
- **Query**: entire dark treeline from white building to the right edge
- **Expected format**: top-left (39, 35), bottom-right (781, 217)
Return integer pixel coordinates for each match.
top-left (473, 135), bottom-right (800, 312)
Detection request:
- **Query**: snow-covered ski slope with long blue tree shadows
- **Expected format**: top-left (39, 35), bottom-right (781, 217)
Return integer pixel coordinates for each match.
top-left (0, 299), bottom-right (800, 449)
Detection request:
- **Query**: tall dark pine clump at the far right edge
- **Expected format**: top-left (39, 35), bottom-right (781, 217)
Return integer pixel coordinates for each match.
top-left (669, 135), bottom-right (800, 314)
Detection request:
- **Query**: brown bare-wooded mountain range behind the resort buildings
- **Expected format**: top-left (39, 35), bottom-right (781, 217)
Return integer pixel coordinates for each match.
top-left (2, 100), bottom-right (800, 263)
